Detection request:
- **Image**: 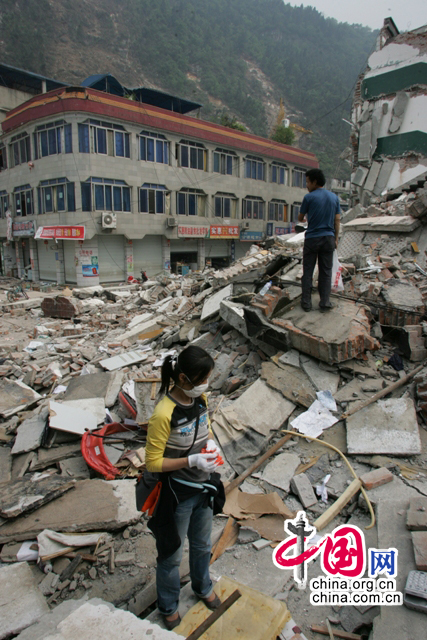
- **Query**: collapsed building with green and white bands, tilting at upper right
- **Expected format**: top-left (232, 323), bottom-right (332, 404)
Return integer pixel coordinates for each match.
top-left (349, 18), bottom-right (427, 206)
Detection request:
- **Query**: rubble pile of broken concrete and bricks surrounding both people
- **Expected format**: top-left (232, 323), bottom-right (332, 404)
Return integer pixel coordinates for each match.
top-left (0, 195), bottom-right (427, 640)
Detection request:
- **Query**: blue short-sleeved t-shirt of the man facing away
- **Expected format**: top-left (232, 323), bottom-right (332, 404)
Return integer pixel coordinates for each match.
top-left (300, 189), bottom-right (341, 238)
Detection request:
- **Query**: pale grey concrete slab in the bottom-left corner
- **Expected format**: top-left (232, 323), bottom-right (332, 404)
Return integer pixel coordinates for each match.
top-left (0, 562), bottom-right (49, 638)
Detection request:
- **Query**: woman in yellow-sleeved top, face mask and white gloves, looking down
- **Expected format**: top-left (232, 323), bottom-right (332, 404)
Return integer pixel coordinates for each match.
top-left (145, 345), bottom-right (222, 629)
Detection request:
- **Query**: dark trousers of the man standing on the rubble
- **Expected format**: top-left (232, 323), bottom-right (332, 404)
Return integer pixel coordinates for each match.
top-left (301, 236), bottom-right (335, 309)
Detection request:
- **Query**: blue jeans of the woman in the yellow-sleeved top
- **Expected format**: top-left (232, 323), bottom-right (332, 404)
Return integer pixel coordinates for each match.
top-left (156, 494), bottom-right (213, 616)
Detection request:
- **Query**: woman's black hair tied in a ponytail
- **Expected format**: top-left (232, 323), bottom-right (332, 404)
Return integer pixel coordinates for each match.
top-left (159, 345), bottom-right (215, 395)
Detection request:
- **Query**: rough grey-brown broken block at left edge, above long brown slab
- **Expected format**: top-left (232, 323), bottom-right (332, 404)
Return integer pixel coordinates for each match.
top-left (0, 474), bottom-right (74, 518)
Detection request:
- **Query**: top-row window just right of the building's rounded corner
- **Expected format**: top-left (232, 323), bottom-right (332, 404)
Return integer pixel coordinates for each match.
top-left (78, 120), bottom-right (130, 158)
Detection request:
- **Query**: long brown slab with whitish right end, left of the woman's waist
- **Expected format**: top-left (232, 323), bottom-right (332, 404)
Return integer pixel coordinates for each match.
top-left (0, 479), bottom-right (142, 543)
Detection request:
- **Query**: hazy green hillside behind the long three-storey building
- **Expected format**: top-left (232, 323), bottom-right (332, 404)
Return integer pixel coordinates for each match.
top-left (0, 0), bottom-right (376, 177)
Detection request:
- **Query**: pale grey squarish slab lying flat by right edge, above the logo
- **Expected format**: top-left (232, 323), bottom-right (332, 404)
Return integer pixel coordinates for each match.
top-left (346, 397), bottom-right (421, 456)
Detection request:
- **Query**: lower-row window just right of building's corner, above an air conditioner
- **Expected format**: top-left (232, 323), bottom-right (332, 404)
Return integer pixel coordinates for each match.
top-left (81, 178), bottom-right (131, 211)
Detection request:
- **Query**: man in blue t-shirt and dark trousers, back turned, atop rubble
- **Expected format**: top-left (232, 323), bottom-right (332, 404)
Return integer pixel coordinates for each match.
top-left (298, 169), bottom-right (341, 312)
